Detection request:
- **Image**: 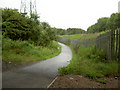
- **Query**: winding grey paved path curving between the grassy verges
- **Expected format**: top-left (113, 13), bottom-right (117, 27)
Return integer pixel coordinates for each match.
top-left (2, 43), bottom-right (72, 88)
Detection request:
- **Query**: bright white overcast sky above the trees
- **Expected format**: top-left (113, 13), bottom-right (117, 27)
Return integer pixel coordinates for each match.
top-left (0, 0), bottom-right (120, 30)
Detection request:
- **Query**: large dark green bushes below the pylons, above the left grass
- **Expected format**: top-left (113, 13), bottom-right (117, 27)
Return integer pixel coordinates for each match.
top-left (2, 9), bottom-right (55, 46)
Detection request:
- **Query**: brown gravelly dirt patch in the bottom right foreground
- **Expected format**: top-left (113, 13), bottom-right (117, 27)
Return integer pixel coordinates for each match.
top-left (49, 75), bottom-right (120, 88)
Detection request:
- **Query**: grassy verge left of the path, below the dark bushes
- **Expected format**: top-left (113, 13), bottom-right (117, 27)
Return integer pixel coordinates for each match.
top-left (2, 38), bottom-right (61, 65)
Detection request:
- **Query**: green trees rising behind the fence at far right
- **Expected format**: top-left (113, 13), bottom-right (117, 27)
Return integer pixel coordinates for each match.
top-left (87, 13), bottom-right (120, 33)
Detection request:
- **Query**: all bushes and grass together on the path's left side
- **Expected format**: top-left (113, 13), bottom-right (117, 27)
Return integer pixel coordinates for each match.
top-left (0, 8), bottom-right (61, 69)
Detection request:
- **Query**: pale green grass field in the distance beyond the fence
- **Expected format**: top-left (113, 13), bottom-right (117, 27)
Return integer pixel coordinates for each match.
top-left (60, 31), bottom-right (107, 41)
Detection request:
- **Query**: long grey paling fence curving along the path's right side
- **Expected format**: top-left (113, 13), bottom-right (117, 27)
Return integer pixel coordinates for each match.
top-left (58, 29), bottom-right (120, 60)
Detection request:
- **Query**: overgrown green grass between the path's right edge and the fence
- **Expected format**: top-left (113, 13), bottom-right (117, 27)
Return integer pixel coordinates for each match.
top-left (59, 46), bottom-right (120, 82)
